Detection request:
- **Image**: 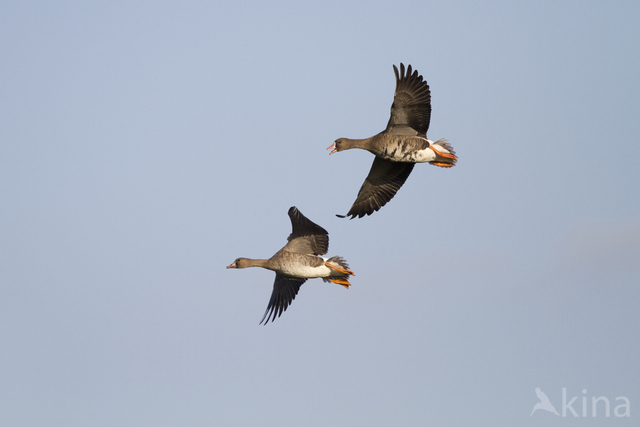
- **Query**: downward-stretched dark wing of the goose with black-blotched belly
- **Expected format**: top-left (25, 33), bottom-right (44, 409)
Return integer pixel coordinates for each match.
top-left (338, 156), bottom-right (414, 219)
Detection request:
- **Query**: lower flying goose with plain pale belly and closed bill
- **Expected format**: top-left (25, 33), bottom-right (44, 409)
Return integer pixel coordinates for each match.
top-left (227, 206), bottom-right (354, 325)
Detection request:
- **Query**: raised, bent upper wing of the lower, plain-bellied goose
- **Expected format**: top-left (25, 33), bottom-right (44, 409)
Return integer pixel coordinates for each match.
top-left (285, 206), bottom-right (329, 255)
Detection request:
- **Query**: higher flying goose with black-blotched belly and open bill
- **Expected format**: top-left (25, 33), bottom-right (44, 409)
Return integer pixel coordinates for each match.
top-left (327, 63), bottom-right (458, 219)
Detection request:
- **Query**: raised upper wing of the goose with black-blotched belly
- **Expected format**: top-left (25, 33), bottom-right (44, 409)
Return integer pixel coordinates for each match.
top-left (385, 64), bottom-right (431, 136)
